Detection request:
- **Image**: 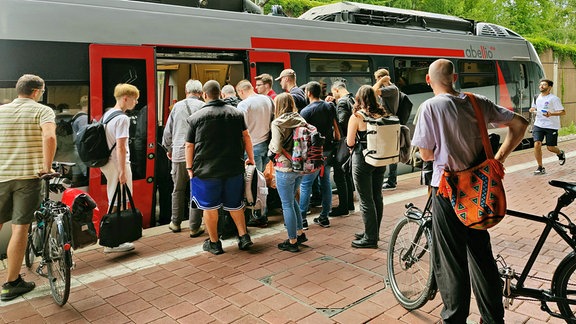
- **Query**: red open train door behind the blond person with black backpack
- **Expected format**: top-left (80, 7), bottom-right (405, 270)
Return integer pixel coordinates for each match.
top-left (89, 44), bottom-right (156, 227)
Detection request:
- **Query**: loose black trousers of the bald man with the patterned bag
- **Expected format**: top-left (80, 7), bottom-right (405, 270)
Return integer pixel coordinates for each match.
top-left (432, 188), bottom-right (504, 323)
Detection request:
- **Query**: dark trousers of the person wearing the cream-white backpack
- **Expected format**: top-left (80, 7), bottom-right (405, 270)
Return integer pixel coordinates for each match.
top-left (352, 151), bottom-right (386, 242)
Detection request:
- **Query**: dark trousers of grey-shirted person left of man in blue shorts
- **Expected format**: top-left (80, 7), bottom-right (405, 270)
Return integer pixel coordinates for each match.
top-left (171, 162), bottom-right (202, 230)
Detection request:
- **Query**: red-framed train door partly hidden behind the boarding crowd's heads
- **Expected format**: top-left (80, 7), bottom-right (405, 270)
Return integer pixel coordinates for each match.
top-left (248, 51), bottom-right (290, 93)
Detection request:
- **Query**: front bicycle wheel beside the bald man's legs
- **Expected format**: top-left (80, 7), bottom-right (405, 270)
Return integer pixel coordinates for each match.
top-left (388, 217), bottom-right (436, 310)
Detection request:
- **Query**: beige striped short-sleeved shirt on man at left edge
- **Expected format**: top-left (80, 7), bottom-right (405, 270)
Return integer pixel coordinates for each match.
top-left (0, 98), bottom-right (56, 182)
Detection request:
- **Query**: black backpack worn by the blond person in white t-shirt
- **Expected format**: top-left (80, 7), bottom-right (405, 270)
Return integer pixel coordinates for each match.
top-left (76, 111), bottom-right (124, 168)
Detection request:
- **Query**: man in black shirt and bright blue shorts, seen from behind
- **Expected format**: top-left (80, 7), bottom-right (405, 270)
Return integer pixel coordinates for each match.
top-left (186, 80), bottom-right (254, 254)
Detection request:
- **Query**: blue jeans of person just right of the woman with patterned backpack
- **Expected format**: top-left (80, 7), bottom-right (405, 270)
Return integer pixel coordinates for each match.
top-left (300, 164), bottom-right (332, 218)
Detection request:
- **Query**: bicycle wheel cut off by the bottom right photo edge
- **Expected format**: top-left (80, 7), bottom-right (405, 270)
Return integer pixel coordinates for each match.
top-left (552, 252), bottom-right (576, 323)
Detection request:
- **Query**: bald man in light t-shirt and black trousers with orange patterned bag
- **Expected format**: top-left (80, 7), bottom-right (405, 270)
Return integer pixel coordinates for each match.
top-left (412, 59), bottom-right (528, 323)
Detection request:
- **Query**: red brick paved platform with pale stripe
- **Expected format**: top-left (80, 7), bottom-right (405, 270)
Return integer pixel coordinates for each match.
top-left (0, 140), bottom-right (576, 324)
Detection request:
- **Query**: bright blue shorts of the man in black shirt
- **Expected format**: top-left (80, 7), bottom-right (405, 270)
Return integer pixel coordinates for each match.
top-left (190, 174), bottom-right (244, 210)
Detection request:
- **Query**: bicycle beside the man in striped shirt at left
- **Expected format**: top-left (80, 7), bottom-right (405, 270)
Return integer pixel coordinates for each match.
top-left (24, 168), bottom-right (73, 306)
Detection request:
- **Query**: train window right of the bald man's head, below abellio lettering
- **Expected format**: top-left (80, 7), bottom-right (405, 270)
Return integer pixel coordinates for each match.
top-left (457, 60), bottom-right (496, 102)
